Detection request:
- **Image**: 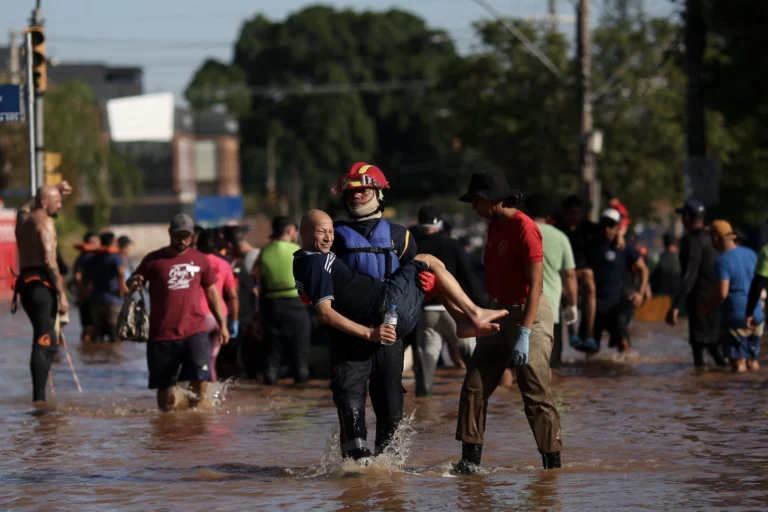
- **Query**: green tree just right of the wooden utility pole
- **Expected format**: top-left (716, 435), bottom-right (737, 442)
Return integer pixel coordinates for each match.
top-left (592, 7), bottom-right (686, 217)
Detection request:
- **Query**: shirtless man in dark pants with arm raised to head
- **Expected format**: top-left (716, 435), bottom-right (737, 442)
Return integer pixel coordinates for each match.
top-left (14, 181), bottom-right (72, 402)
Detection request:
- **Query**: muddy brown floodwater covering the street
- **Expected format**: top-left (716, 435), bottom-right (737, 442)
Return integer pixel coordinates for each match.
top-left (0, 305), bottom-right (768, 511)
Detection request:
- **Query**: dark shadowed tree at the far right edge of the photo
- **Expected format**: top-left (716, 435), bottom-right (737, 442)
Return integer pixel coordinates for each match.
top-left (702, 0), bottom-right (768, 224)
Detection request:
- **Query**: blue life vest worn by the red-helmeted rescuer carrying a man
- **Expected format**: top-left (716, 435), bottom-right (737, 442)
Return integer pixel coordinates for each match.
top-left (334, 219), bottom-right (400, 279)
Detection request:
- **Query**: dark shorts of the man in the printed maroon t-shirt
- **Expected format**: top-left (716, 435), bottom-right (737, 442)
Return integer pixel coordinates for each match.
top-left (147, 332), bottom-right (211, 389)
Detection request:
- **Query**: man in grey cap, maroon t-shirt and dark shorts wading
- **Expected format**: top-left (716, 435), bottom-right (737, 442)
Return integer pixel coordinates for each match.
top-left (129, 213), bottom-right (229, 411)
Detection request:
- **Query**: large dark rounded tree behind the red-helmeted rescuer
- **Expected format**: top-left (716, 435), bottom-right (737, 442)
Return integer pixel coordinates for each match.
top-left (187, 6), bottom-right (455, 206)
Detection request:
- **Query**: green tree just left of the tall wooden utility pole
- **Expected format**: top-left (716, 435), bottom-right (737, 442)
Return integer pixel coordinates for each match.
top-left (441, 21), bottom-right (578, 195)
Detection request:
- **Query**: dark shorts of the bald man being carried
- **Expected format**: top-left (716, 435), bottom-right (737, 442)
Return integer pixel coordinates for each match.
top-left (377, 260), bottom-right (429, 338)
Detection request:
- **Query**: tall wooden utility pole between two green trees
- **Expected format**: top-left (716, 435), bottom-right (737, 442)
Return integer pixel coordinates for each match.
top-left (576, 0), bottom-right (600, 221)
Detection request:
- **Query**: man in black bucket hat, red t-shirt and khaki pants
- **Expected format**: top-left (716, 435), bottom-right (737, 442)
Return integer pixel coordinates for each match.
top-left (456, 170), bottom-right (562, 473)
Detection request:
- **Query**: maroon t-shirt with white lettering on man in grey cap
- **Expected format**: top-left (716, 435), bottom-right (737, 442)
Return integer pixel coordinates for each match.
top-left (134, 247), bottom-right (216, 341)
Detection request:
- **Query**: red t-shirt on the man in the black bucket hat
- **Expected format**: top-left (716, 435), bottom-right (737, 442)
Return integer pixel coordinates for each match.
top-left (483, 211), bottom-right (544, 304)
